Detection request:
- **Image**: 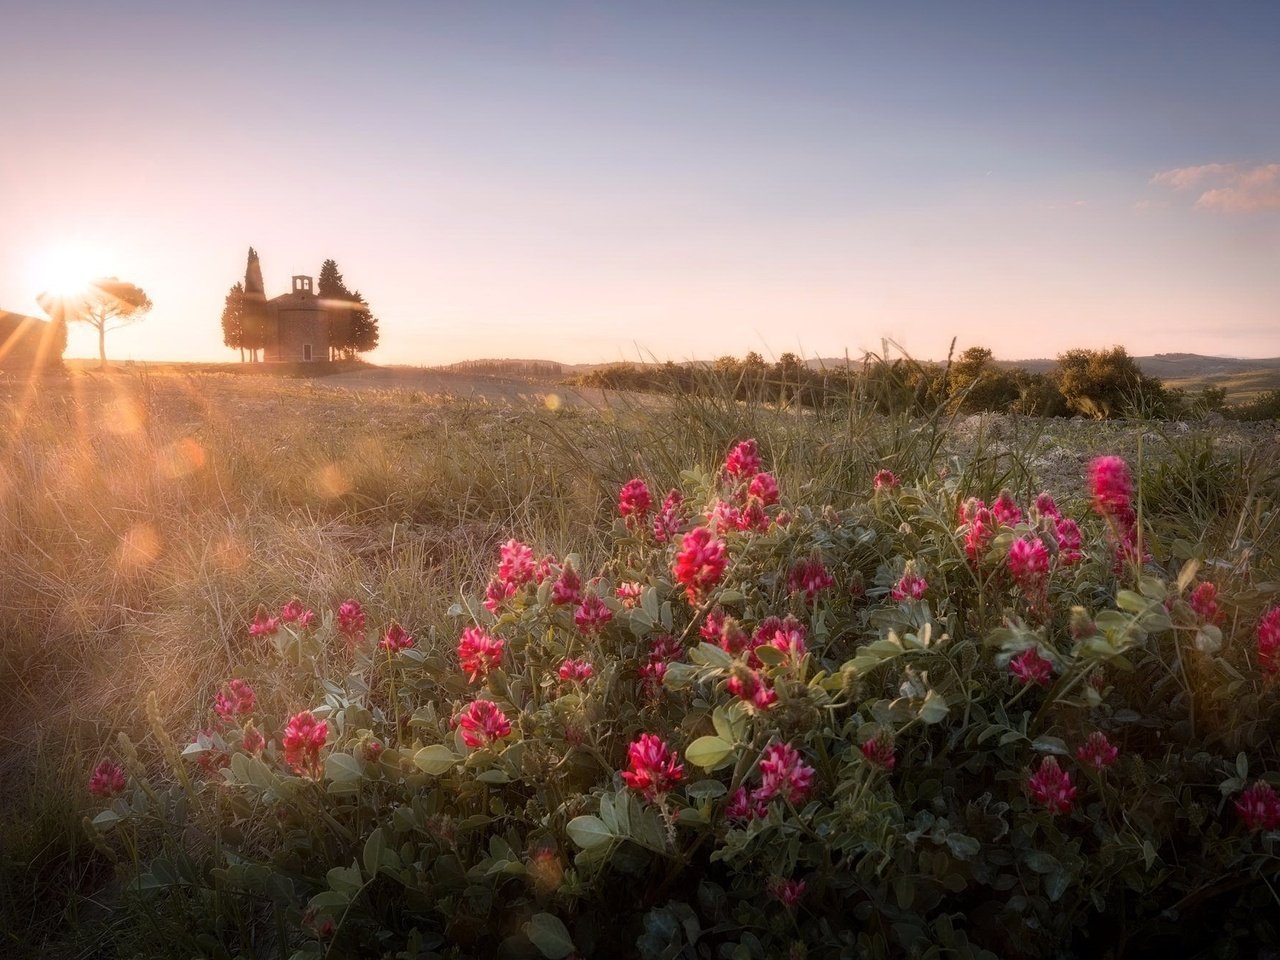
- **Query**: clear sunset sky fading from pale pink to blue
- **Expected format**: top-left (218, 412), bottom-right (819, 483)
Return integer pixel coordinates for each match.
top-left (0, 0), bottom-right (1280, 365)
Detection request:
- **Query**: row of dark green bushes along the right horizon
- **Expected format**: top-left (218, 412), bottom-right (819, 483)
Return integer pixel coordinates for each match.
top-left (575, 347), bottom-right (1280, 420)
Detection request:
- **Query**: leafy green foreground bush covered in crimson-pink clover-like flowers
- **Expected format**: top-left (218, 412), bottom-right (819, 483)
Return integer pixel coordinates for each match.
top-left (88, 442), bottom-right (1280, 957)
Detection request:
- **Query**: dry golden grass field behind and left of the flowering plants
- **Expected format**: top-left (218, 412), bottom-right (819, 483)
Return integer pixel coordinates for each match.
top-left (0, 369), bottom-right (1280, 956)
